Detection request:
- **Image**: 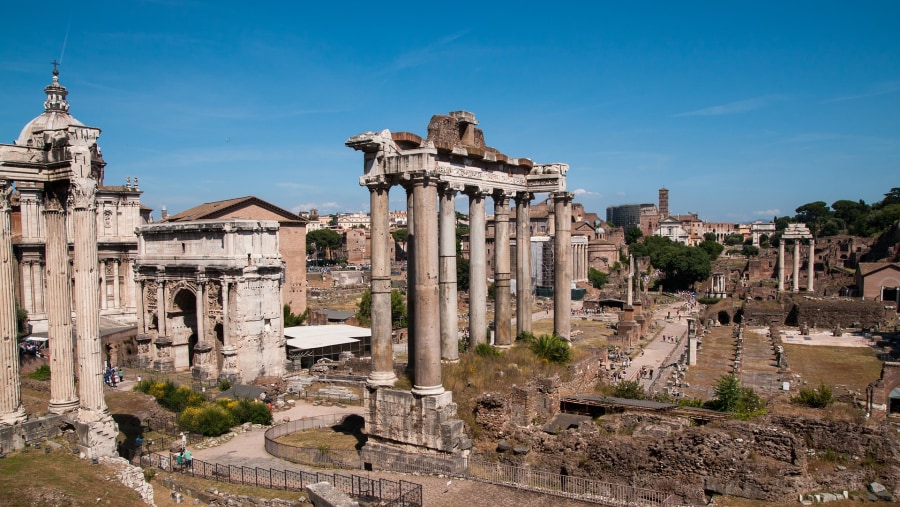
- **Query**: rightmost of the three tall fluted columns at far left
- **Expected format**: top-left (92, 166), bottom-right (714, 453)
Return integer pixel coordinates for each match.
top-left (71, 178), bottom-right (109, 422)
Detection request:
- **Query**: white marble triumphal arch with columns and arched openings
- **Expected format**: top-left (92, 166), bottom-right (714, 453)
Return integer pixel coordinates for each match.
top-left (135, 218), bottom-right (285, 382)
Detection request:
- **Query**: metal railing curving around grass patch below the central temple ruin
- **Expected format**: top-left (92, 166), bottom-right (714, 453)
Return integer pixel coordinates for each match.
top-left (265, 414), bottom-right (675, 507)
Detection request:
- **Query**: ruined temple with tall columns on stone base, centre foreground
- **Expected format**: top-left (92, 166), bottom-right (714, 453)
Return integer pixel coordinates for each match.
top-left (345, 111), bottom-right (573, 452)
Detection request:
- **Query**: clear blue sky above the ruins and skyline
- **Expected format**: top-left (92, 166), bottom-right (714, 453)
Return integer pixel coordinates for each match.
top-left (0, 0), bottom-right (900, 222)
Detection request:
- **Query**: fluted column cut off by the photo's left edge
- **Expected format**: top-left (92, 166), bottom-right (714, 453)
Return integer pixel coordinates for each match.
top-left (0, 180), bottom-right (25, 426)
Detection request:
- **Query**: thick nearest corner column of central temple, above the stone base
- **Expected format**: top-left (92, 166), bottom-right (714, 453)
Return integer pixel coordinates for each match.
top-left (412, 175), bottom-right (444, 396)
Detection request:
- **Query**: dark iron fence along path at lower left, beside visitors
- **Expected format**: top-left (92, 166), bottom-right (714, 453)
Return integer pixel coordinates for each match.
top-left (140, 452), bottom-right (422, 507)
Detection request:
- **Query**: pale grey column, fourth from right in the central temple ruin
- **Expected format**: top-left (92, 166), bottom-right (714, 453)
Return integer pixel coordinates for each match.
top-left (466, 188), bottom-right (487, 349)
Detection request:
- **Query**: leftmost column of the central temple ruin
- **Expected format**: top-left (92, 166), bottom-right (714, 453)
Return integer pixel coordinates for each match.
top-left (367, 183), bottom-right (397, 387)
